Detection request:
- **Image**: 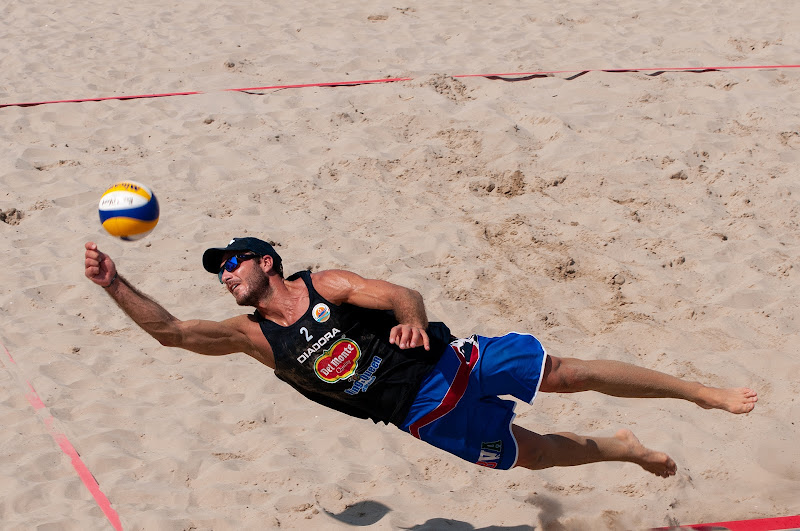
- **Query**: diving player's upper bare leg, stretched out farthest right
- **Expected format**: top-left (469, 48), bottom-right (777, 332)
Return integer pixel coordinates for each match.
top-left (539, 356), bottom-right (758, 413)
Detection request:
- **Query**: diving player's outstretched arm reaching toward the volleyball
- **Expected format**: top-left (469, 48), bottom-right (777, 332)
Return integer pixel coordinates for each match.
top-left (85, 242), bottom-right (260, 358)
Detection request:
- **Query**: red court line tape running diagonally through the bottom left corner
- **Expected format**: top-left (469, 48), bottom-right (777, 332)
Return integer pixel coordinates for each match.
top-left (0, 343), bottom-right (122, 531)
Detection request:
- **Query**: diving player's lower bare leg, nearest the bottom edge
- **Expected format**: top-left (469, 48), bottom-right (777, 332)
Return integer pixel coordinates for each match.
top-left (511, 424), bottom-right (677, 478)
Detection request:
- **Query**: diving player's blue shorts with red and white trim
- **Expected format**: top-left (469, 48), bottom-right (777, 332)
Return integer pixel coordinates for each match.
top-left (399, 333), bottom-right (547, 470)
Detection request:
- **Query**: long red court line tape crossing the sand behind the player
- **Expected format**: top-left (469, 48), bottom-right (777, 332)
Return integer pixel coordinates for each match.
top-left (0, 65), bottom-right (800, 109)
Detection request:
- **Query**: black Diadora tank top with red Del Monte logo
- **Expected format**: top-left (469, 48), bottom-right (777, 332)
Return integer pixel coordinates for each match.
top-left (254, 271), bottom-right (451, 424)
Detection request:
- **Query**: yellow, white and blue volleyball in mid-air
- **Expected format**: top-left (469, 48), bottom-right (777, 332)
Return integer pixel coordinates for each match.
top-left (99, 181), bottom-right (159, 240)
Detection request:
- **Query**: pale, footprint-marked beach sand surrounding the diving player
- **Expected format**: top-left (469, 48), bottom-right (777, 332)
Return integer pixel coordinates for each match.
top-left (0, 0), bottom-right (800, 530)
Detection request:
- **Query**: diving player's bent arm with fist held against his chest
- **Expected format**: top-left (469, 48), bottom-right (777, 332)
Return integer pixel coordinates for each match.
top-left (312, 269), bottom-right (431, 350)
